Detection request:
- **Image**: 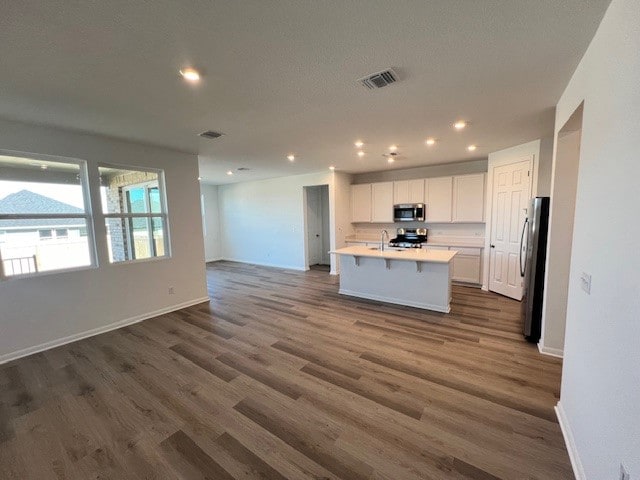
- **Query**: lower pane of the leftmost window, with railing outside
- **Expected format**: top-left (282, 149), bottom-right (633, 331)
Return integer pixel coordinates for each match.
top-left (0, 218), bottom-right (91, 276)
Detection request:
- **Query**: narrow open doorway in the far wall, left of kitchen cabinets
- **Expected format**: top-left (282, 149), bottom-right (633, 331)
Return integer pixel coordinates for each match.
top-left (304, 185), bottom-right (331, 268)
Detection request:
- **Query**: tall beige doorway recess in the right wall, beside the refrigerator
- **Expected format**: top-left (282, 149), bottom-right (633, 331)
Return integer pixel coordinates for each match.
top-left (540, 104), bottom-right (583, 356)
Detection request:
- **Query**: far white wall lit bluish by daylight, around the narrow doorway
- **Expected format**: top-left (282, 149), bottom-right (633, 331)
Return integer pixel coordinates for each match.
top-left (218, 172), bottom-right (335, 270)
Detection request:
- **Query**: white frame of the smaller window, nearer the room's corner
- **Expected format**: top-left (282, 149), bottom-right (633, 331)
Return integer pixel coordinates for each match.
top-left (98, 163), bottom-right (171, 265)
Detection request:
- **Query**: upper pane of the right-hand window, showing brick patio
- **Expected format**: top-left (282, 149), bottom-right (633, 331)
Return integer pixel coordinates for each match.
top-left (99, 167), bottom-right (159, 213)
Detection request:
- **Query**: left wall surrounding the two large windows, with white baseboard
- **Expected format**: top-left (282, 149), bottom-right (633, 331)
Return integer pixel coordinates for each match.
top-left (0, 120), bottom-right (207, 361)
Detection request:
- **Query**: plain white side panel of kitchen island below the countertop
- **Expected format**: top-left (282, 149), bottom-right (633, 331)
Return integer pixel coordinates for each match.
top-left (340, 255), bottom-right (451, 313)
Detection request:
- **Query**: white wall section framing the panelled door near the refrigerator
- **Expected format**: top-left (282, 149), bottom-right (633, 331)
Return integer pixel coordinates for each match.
top-left (482, 140), bottom-right (541, 290)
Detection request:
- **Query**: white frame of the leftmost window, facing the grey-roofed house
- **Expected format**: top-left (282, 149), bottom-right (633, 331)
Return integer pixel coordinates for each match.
top-left (0, 150), bottom-right (98, 280)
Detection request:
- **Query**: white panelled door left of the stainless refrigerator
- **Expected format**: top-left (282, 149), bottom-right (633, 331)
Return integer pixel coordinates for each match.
top-left (489, 160), bottom-right (531, 300)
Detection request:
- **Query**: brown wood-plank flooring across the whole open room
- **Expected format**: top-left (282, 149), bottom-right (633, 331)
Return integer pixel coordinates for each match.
top-left (0, 262), bottom-right (573, 480)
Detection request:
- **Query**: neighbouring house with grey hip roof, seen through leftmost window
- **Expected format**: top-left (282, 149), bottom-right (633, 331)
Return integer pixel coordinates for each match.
top-left (0, 190), bottom-right (91, 276)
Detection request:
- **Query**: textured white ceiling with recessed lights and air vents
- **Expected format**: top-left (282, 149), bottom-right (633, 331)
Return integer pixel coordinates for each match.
top-left (0, 0), bottom-right (610, 183)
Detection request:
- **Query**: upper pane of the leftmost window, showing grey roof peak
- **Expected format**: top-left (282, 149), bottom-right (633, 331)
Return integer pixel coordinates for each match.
top-left (0, 155), bottom-right (85, 215)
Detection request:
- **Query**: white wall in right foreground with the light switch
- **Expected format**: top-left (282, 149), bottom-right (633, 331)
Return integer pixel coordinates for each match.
top-left (556, 0), bottom-right (640, 480)
